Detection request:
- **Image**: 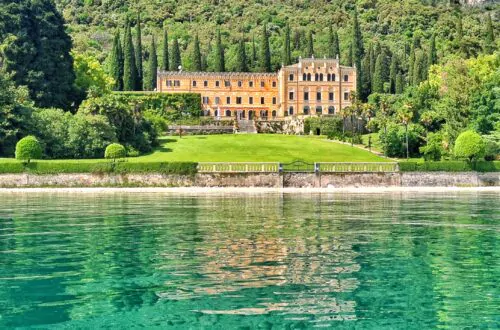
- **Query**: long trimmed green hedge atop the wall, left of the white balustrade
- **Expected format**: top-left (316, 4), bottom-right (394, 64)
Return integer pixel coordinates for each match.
top-left (0, 161), bottom-right (198, 175)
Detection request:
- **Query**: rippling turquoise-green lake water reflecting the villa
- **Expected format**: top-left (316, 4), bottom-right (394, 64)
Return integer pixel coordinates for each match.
top-left (0, 193), bottom-right (500, 329)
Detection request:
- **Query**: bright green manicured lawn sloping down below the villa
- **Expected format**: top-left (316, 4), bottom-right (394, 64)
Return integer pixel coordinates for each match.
top-left (129, 134), bottom-right (388, 163)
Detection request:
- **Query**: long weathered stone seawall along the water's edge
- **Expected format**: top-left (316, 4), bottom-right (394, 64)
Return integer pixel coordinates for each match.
top-left (0, 172), bottom-right (500, 188)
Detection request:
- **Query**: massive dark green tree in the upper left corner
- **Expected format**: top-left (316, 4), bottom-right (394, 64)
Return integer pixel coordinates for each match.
top-left (0, 0), bottom-right (76, 109)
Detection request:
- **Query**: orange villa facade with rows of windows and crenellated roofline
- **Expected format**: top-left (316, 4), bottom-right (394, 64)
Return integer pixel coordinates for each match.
top-left (157, 58), bottom-right (357, 119)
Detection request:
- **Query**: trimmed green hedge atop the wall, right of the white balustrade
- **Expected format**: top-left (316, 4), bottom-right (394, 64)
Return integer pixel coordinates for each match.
top-left (399, 161), bottom-right (500, 172)
